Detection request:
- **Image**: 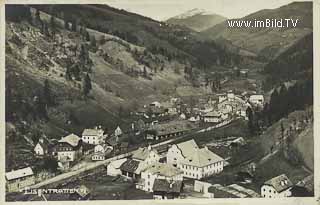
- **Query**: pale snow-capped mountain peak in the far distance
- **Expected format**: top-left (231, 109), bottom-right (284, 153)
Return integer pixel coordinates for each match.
top-left (166, 9), bottom-right (226, 32)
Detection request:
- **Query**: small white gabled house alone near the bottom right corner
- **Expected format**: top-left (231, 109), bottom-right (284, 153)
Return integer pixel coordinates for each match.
top-left (261, 174), bottom-right (293, 198)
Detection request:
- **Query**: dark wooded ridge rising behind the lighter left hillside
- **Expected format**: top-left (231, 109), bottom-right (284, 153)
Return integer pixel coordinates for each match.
top-left (32, 5), bottom-right (235, 67)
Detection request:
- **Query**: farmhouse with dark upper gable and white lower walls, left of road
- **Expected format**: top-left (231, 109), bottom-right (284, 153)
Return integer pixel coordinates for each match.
top-left (56, 134), bottom-right (82, 162)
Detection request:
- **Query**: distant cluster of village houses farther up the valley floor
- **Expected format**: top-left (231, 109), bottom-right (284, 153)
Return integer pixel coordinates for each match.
top-left (136, 90), bottom-right (264, 128)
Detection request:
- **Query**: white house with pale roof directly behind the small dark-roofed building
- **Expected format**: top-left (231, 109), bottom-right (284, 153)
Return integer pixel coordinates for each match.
top-left (136, 163), bottom-right (183, 192)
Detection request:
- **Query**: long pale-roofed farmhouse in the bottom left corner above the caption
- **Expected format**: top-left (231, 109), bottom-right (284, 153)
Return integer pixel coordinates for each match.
top-left (5, 167), bottom-right (35, 192)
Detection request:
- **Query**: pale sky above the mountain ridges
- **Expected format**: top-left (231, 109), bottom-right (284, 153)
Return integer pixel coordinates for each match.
top-left (105, 0), bottom-right (303, 20)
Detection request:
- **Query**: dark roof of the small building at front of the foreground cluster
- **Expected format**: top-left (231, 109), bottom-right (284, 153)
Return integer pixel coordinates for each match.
top-left (153, 179), bottom-right (182, 193)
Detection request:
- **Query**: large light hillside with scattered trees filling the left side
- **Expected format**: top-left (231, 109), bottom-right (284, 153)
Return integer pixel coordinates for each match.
top-left (5, 6), bottom-right (210, 170)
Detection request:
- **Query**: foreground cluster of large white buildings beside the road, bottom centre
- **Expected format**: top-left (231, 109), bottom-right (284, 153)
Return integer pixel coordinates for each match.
top-left (119, 140), bottom-right (224, 199)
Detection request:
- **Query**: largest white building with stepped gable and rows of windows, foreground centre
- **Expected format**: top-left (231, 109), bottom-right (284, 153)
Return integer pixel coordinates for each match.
top-left (167, 140), bottom-right (224, 179)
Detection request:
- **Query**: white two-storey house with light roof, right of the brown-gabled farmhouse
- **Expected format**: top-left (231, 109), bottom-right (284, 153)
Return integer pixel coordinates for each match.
top-left (82, 127), bottom-right (105, 145)
